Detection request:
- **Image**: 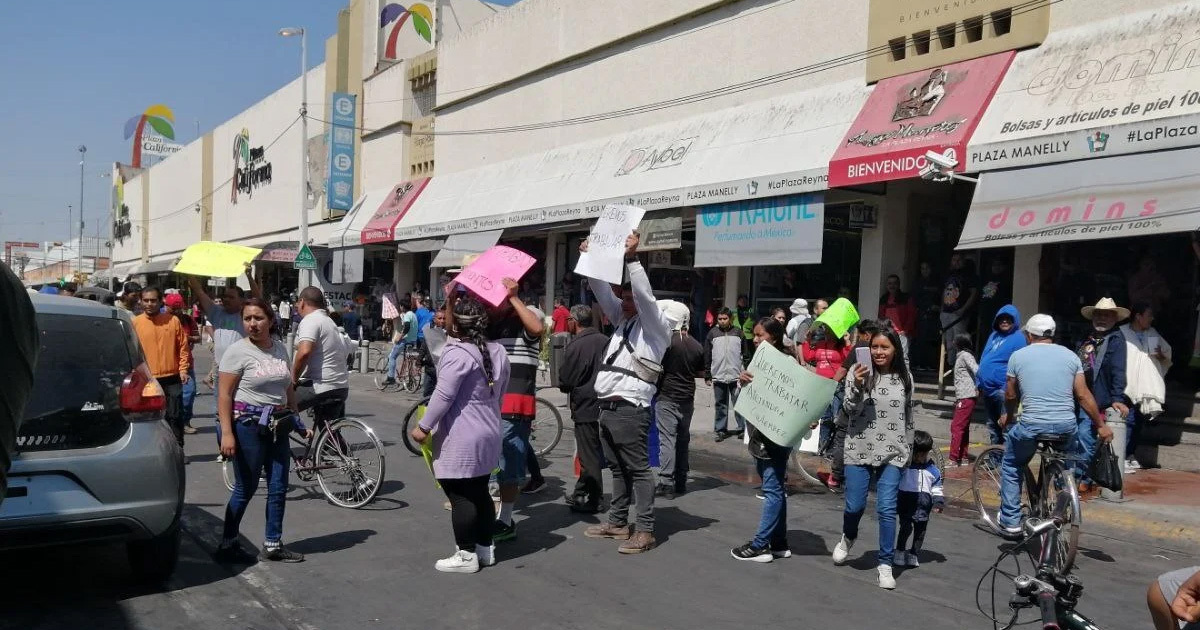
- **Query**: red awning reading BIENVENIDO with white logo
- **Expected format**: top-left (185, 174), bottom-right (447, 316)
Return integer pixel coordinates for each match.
top-left (829, 52), bottom-right (1014, 187)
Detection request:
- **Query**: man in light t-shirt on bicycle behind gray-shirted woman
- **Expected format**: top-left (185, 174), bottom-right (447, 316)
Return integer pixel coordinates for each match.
top-left (292, 287), bottom-right (350, 428)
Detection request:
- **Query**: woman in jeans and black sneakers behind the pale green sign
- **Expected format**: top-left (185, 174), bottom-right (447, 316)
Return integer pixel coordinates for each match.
top-left (730, 317), bottom-right (801, 563)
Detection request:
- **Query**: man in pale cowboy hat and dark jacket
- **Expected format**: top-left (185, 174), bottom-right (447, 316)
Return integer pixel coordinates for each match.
top-left (1076, 298), bottom-right (1129, 492)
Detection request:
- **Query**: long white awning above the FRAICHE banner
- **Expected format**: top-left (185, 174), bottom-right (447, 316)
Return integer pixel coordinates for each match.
top-left (395, 80), bottom-right (871, 240)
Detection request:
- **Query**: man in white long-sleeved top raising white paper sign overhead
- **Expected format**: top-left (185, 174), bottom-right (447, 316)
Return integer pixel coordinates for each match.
top-left (576, 228), bottom-right (671, 553)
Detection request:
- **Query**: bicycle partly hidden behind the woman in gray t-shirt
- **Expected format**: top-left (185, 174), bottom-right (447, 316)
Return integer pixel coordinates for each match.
top-left (221, 402), bottom-right (386, 509)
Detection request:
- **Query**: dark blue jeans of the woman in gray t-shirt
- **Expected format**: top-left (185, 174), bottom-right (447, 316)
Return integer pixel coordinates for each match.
top-left (224, 420), bottom-right (290, 542)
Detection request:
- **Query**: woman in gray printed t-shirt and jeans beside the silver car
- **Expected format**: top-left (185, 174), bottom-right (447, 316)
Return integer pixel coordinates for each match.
top-left (214, 298), bottom-right (304, 564)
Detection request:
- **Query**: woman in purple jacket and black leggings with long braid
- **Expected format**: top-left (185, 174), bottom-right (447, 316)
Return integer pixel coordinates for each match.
top-left (413, 296), bottom-right (509, 574)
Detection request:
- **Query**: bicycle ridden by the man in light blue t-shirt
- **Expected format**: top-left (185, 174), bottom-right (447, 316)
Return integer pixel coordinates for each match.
top-left (971, 433), bottom-right (1084, 575)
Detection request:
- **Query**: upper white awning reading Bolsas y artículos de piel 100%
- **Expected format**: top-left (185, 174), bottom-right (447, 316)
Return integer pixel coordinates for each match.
top-left (966, 2), bottom-right (1200, 172)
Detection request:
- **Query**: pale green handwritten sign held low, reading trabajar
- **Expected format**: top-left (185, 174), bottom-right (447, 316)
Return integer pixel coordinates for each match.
top-left (733, 343), bottom-right (838, 448)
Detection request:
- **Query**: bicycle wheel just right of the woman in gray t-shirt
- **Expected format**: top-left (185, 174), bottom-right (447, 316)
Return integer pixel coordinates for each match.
top-left (316, 418), bottom-right (385, 508)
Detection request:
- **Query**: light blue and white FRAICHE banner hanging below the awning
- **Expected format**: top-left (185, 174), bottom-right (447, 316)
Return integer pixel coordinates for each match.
top-left (696, 193), bottom-right (824, 266)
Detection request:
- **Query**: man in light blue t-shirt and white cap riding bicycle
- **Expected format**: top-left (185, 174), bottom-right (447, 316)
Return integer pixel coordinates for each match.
top-left (998, 313), bottom-right (1112, 538)
